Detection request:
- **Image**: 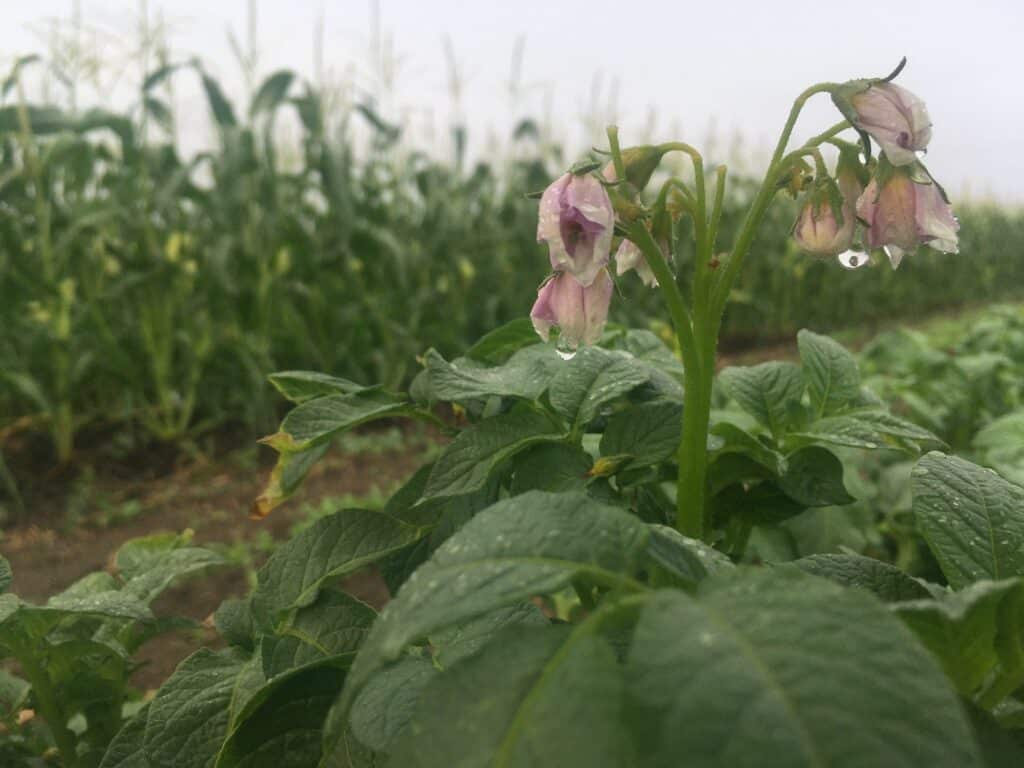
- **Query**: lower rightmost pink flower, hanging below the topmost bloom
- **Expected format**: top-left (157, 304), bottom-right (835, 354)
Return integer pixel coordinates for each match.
top-left (857, 168), bottom-right (959, 268)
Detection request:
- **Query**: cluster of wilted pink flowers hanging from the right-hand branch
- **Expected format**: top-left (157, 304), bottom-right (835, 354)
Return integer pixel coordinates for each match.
top-left (794, 80), bottom-right (959, 267)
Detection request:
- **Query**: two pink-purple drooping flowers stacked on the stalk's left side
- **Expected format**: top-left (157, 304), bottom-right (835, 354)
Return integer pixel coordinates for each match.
top-left (529, 173), bottom-right (615, 352)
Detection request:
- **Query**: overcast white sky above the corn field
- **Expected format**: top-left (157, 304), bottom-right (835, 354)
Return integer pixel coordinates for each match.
top-left (0, 0), bottom-right (1024, 202)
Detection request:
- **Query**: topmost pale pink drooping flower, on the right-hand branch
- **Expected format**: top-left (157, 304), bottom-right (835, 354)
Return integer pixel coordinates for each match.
top-left (850, 83), bottom-right (932, 166)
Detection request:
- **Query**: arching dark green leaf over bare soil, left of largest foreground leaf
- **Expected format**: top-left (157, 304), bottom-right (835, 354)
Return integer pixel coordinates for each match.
top-left (253, 509), bottom-right (425, 627)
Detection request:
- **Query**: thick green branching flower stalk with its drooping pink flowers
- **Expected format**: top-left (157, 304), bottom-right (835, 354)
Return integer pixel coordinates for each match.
top-left (535, 63), bottom-right (956, 548)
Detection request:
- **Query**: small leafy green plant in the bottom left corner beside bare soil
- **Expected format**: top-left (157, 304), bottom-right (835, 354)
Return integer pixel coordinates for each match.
top-left (0, 532), bottom-right (224, 768)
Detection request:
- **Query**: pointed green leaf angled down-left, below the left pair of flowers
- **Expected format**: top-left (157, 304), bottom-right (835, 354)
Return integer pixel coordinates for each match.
top-left (423, 406), bottom-right (565, 500)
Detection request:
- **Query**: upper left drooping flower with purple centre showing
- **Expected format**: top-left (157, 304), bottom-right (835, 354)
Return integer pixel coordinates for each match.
top-left (537, 173), bottom-right (615, 286)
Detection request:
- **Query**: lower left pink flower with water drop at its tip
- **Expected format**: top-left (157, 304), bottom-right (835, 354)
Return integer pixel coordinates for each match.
top-left (529, 268), bottom-right (613, 350)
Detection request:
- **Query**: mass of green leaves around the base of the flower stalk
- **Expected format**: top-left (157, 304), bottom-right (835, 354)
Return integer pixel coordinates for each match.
top-left (2, 324), bottom-right (999, 768)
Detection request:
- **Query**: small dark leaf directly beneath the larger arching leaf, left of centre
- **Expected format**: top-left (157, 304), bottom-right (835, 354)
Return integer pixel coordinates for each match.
top-left (260, 589), bottom-right (377, 680)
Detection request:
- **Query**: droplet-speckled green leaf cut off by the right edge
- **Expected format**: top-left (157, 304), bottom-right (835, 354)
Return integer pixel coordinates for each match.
top-left (911, 452), bottom-right (1024, 589)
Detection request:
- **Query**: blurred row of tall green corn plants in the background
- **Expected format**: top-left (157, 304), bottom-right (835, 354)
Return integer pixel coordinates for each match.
top-left (0, 59), bottom-right (1024, 461)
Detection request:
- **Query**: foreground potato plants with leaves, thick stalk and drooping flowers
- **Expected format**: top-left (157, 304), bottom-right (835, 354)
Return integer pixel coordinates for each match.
top-left (0, 61), bottom-right (1024, 768)
